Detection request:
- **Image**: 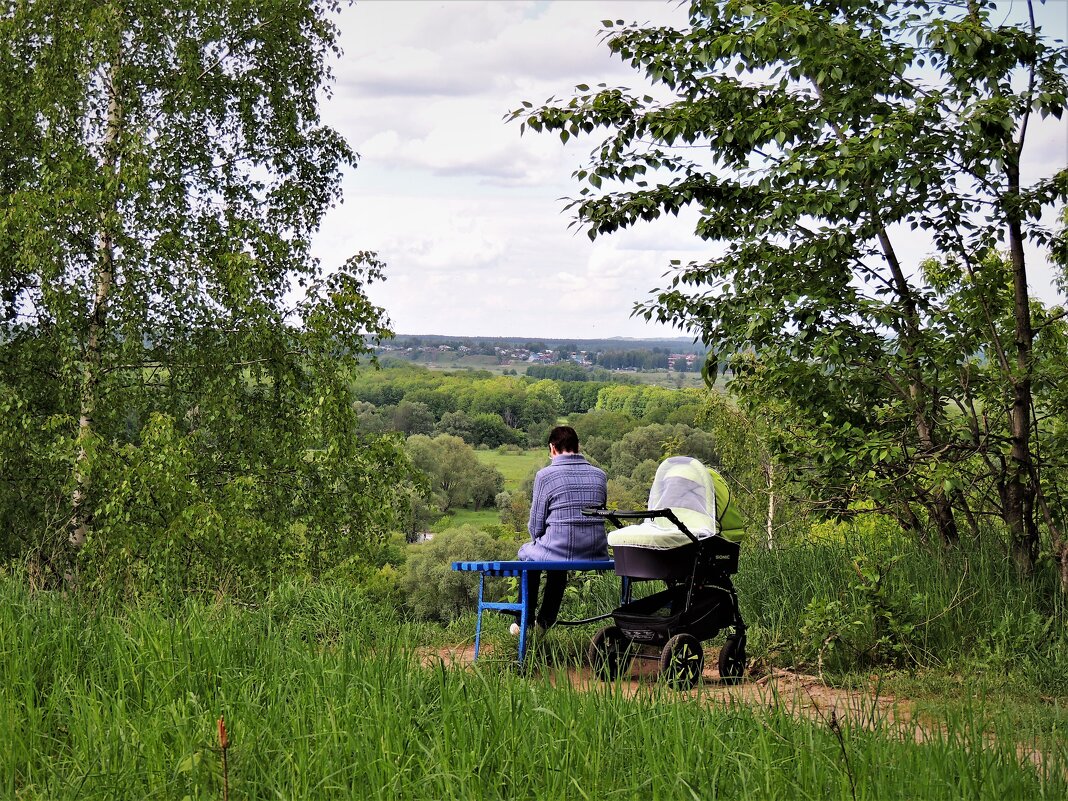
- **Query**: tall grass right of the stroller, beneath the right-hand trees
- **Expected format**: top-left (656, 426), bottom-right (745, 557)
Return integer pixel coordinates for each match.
top-left (735, 541), bottom-right (1068, 696)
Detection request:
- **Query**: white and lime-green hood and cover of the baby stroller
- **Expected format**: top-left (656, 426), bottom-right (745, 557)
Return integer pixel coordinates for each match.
top-left (608, 456), bottom-right (744, 549)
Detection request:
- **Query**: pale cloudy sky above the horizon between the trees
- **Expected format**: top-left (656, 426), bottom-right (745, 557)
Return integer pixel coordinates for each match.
top-left (316, 0), bottom-right (1068, 339)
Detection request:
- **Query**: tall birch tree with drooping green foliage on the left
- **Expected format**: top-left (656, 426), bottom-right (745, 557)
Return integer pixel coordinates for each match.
top-left (0, 0), bottom-right (404, 581)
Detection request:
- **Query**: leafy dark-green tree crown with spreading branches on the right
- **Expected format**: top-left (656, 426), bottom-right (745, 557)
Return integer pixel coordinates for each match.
top-left (509, 0), bottom-right (1068, 576)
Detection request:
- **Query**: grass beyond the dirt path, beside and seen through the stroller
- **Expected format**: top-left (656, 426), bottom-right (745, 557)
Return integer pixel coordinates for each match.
top-left (529, 534), bottom-right (1068, 760)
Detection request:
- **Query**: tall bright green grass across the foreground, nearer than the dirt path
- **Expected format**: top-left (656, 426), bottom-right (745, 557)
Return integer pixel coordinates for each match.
top-left (0, 582), bottom-right (1068, 800)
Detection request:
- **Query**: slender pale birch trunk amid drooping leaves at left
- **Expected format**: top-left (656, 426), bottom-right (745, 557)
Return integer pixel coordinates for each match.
top-left (68, 60), bottom-right (122, 568)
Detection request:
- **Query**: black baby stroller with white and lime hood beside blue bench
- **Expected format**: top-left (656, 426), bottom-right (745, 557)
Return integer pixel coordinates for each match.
top-left (583, 456), bottom-right (747, 689)
